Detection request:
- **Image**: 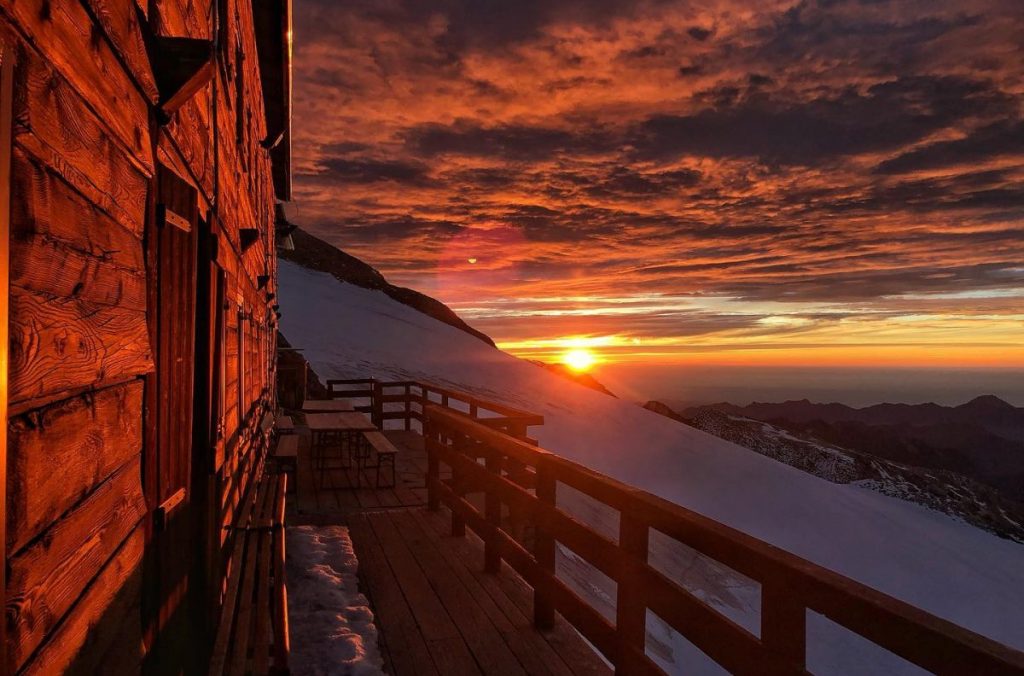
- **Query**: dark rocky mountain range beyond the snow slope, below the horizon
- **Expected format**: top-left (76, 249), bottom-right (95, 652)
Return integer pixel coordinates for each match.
top-left (646, 395), bottom-right (1024, 542)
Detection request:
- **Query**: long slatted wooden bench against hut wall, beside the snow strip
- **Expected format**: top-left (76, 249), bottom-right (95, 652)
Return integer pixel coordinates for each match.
top-left (210, 472), bottom-right (289, 676)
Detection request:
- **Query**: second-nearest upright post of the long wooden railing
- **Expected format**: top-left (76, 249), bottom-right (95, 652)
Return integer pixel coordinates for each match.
top-left (615, 512), bottom-right (650, 674)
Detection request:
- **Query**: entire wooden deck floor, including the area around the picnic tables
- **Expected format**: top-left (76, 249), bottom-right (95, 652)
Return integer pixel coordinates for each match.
top-left (288, 419), bottom-right (611, 676)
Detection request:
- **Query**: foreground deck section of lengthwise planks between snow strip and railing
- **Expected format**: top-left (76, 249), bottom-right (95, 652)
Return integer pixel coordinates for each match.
top-left (348, 508), bottom-right (611, 676)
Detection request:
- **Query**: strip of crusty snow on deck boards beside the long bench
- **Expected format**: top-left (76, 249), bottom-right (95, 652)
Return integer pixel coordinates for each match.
top-left (287, 525), bottom-right (383, 676)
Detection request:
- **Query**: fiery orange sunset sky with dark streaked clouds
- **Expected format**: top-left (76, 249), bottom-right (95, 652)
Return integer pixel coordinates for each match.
top-left (289, 0), bottom-right (1024, 369)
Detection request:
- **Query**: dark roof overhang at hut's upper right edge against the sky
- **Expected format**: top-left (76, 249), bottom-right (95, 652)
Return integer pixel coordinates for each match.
top-left (253, 0), bottom-right (292, 201)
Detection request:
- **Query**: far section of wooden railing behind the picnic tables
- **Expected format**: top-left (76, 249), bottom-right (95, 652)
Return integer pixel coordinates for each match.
top-left (327, 378), bottom-right (544, 443)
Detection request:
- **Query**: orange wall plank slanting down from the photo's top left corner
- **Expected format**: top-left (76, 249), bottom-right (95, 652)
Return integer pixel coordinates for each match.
top-left (5, 0), bottom-right (152, 168)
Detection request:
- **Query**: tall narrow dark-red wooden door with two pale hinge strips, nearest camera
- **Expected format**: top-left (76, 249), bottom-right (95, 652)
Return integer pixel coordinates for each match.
top-left (146, 166), bottom-right (202, 674)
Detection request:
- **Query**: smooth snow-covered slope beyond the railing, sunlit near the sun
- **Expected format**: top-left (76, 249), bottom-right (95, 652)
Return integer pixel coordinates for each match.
top-left (281, 261), bottom-right (1024, 673)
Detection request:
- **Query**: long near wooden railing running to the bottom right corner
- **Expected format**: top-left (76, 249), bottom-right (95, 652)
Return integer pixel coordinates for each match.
top-left (422, 405), bottom-right (1024, 675)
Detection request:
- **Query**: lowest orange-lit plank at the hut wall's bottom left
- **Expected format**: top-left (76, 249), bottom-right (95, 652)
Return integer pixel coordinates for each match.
top-left (22, 527), bottom-right (145, 676)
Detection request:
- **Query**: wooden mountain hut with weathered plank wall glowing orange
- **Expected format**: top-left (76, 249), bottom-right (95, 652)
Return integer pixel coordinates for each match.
top-left (0, 0), bottom-right (291, 674)
